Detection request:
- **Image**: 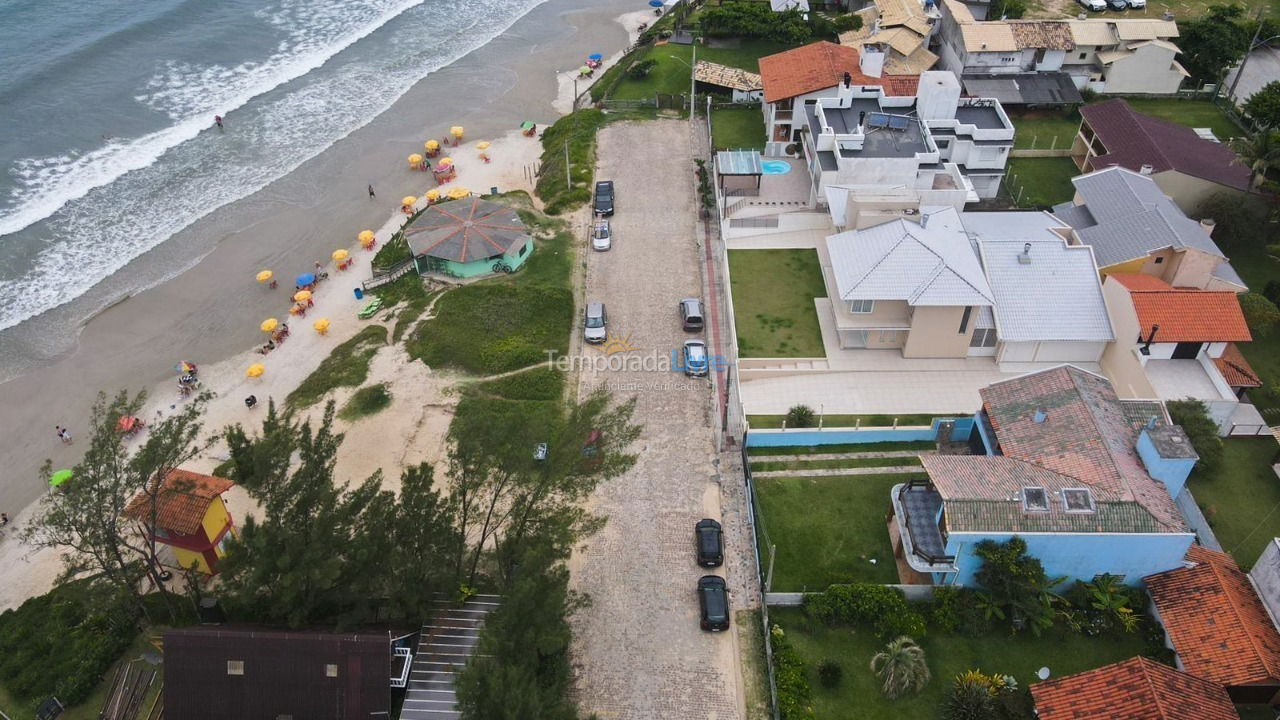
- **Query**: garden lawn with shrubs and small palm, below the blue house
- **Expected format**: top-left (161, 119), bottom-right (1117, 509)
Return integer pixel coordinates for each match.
top-left (769, 607), bottom-right (1143, 720)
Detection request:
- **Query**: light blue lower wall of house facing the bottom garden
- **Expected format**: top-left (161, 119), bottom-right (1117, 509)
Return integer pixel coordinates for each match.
top-left (947, 532), bottom-right (1196, 585)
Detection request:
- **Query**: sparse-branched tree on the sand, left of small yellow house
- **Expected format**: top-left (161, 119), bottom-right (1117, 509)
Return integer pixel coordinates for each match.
top-left (22, 391), bottom-right (207, 618)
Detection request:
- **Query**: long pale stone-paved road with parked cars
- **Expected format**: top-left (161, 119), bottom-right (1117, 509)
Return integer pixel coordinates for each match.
top-left (570, 120), bottom-right (751, 720)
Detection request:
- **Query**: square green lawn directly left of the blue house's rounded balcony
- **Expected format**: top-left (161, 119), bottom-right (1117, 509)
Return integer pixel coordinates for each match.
top-left (755, 473), bottom-right (923, 592)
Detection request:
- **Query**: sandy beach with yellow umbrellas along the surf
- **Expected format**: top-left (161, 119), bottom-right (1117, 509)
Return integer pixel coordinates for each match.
top-left (0, 0), bottom-right (650, 610)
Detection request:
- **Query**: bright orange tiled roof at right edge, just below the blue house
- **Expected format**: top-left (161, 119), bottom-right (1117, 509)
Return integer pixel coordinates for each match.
top-left (1146, 546), bottom-right (1280, 685)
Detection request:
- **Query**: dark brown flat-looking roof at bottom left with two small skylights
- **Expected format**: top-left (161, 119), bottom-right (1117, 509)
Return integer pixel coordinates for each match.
top-left (164, 626), bottom-right (392, 720)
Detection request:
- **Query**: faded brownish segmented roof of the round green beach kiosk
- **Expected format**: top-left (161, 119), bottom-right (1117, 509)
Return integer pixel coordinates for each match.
top-left (404, 197), bottom-right (529, 263)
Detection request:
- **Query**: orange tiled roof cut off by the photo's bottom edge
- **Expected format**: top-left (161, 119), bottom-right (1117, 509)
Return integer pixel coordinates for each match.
top-left (1032, 657), bottom-right (1240, 720)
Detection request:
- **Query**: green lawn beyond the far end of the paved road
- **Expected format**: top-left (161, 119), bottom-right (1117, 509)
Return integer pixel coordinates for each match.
top-left (604, 40), bottom-right (791, 101)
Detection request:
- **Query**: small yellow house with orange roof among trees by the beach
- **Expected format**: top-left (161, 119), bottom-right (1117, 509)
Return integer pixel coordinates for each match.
top-left (124, 469), bottom-right (236, 575)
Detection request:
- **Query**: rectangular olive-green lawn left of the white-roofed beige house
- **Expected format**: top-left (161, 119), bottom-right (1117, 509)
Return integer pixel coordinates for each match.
top-left (728, 250), bottom-right (827, 357)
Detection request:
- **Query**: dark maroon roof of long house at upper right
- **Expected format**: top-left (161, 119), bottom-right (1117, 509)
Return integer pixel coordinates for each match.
top-left (1080, 99), bottom-right (1252, 191)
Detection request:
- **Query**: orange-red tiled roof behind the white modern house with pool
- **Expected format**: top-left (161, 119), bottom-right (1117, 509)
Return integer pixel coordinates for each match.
top-left (759, 40), bottom-right (920, 102)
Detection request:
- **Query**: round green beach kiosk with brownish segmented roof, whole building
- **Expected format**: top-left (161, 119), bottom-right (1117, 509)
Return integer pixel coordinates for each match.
top-left (404, 197), bottom-right (534, 278)
